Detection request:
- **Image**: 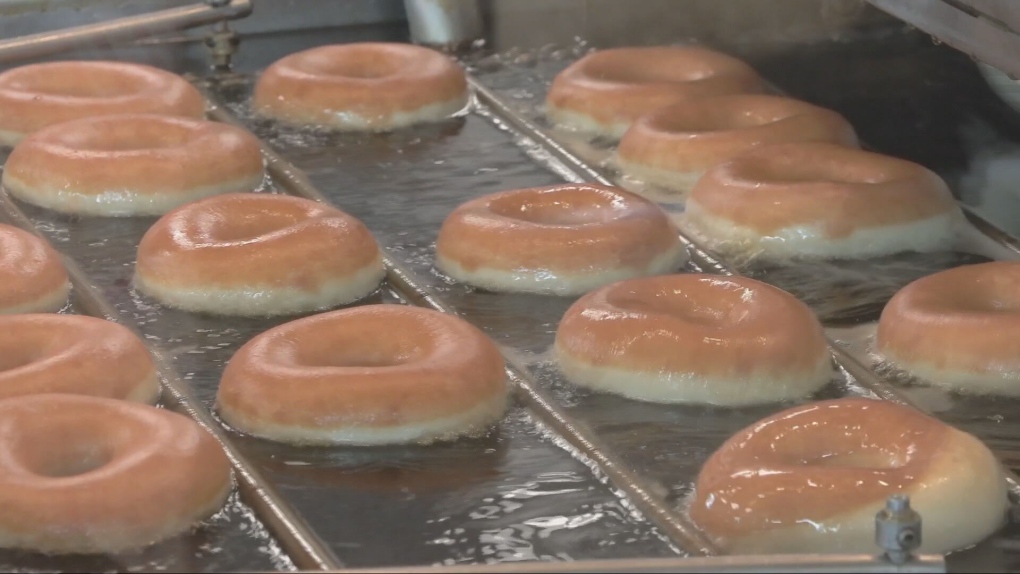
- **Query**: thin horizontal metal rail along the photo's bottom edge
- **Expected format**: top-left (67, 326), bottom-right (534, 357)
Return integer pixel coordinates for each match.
top-left (322, 555), bottom-right (946, 574)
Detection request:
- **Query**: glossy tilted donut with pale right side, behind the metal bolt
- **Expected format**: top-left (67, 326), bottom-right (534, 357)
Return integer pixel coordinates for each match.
top-left (690, 399), bottom-right (1009, 555)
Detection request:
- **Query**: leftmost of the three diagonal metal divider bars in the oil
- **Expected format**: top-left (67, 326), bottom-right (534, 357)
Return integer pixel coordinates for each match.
top-left (0, 191), bottom-right (344, 570)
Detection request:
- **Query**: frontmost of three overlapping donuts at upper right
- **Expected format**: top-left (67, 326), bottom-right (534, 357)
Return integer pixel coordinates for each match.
top-left (684, 143), bottom-right (963, 258)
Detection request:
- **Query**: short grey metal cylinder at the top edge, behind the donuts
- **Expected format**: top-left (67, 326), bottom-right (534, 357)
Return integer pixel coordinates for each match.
top-left (404, 0), bottom-right (483, 48)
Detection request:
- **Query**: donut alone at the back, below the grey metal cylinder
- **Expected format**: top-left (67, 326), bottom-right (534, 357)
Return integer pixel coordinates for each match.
top-left (253, 43), bottom-right (468, 132)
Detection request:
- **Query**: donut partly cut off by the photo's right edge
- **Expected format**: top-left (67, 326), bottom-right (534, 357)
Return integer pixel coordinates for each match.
top-left (875, 261), bottom-right (1020, 397)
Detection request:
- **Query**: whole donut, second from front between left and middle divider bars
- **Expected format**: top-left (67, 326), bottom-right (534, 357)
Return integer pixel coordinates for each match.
top-left (135, 194), bottom-right (386, 316)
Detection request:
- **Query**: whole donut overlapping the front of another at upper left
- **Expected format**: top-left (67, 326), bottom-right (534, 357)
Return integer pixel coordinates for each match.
top-left (3, 114), bottom-right (263, 216)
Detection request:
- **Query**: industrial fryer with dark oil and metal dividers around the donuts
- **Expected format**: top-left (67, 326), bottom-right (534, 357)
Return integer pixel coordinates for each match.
top-left (0, 0), bottom-right (1020, 572)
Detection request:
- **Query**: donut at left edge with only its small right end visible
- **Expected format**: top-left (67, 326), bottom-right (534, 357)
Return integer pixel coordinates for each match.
top-left (0, 223), bottom-right (70, 315)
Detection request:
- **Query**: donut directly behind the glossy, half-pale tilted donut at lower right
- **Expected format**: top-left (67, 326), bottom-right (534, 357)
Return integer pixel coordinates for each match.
top-left (554, 273), bottom-right (832, 406)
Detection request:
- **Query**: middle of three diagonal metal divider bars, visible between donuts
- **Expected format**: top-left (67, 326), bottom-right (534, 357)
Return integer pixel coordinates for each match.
top-left (198, 92), bottom-right (718, 556)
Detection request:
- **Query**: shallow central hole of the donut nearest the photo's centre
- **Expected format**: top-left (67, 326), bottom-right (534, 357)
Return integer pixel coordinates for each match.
top-left (489, 188), bottom-right (627, 225)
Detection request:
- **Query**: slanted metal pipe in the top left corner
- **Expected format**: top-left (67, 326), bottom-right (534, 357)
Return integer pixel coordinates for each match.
top-left (0, 0), bottom-right (252, 62)
